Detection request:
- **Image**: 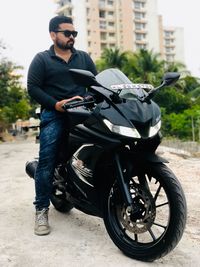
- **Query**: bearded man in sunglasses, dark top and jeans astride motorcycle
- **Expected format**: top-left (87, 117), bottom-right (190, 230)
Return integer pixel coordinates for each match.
top-left (28, 16), bottom-right (97, 235)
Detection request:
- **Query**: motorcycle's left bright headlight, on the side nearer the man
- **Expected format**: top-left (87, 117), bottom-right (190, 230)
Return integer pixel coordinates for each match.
top-left (103, 119), bottom-right (141, 139)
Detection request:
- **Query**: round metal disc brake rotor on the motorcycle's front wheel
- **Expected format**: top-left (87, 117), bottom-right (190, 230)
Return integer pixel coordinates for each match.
top-left (117, 184), bottom-right (156, 234)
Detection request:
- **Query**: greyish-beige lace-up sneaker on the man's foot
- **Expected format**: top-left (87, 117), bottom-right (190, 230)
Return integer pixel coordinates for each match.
top-left (34, 209), bottom-right (50, 235)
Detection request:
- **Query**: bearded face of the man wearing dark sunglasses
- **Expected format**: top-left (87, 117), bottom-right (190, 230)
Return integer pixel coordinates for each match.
top-left (51, 23), bottom-right (76, 50)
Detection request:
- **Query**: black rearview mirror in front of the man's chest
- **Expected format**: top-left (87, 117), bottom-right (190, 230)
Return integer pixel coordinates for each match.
top-left (69, 69), bottom-right (100, 87)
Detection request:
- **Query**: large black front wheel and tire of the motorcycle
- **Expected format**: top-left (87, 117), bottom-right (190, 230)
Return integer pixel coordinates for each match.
top-left (104, 163), bottom-right (187, 261)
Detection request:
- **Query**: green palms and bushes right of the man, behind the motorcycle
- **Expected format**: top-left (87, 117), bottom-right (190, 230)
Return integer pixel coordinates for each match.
top-left (96, 49), bottom-right (200, 141)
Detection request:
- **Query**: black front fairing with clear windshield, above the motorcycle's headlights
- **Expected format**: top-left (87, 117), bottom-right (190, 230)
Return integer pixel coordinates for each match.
top-left (92, 69), bottom-right (160, 138)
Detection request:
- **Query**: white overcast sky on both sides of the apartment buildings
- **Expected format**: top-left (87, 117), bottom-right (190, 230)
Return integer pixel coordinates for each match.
top-left (0, 0), bottom-right (200, 85)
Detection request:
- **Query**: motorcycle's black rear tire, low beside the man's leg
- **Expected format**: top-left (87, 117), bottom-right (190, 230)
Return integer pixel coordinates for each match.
top-left (51, 192), bottom-right (73, 213)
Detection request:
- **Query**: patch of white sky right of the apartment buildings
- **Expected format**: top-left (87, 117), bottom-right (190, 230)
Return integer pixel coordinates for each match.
top-left (158, 0), bottom-right (200, 77)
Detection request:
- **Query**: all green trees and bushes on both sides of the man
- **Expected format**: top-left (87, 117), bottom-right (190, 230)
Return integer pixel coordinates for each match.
top-left (0, 40), bottom-right (200, 141)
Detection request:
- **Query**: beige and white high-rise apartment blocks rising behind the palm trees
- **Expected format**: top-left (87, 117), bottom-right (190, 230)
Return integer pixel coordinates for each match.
top-left (54, 0), bottom-right (183, 61)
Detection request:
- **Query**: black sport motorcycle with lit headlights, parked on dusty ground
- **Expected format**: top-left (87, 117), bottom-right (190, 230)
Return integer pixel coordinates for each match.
top-left (26, 69), bottom-right (187, 261)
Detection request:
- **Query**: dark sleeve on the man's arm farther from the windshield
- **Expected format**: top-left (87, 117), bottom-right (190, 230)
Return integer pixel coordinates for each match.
top-left (27, 53), bottom-right (57, 109)
